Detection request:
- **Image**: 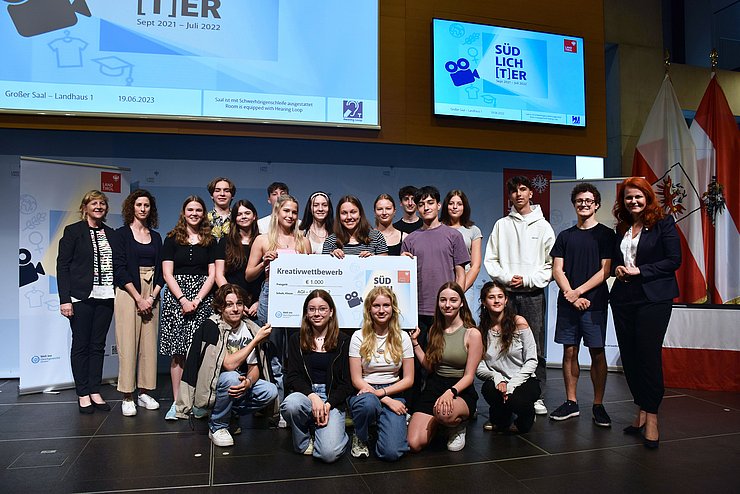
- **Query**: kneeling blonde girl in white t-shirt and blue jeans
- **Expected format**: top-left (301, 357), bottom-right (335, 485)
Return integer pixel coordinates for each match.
top-left (349, 286), bottom-right (414, 461)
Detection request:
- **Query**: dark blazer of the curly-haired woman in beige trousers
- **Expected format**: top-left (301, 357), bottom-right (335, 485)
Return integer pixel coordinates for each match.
top-left (113, 225), bottom-right (164, 293)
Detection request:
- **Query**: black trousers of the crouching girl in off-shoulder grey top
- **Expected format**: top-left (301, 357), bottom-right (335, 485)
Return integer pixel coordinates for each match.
top-left (480, 376), bottom-right (540, 434)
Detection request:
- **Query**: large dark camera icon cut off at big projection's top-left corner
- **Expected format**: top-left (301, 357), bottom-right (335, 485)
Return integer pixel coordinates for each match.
top-left (5, 0), bottom-right (92, 38)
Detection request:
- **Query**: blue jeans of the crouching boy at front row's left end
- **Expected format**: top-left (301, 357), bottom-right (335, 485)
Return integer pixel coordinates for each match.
top-left (208, 371), bottom-right (277, 432)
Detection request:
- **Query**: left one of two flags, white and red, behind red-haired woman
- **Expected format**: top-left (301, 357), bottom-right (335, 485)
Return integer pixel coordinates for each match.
top-left (632, 74), bottom-right (706, 303)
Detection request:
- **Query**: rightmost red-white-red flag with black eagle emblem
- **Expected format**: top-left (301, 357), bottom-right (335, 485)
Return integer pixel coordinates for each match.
top-left (691, 73), bottom-right (740, 304)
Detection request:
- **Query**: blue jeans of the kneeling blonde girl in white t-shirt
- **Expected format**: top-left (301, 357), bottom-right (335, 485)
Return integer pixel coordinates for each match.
top-left (349, 385), bottom-right (409, 461)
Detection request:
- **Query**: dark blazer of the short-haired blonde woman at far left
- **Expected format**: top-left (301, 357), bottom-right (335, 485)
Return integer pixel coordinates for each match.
top-left (57, 221), bottom-right (116, 304)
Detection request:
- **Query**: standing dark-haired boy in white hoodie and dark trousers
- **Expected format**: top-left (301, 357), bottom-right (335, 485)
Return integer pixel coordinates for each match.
top-left (483, 175), bottom-right (555, 415)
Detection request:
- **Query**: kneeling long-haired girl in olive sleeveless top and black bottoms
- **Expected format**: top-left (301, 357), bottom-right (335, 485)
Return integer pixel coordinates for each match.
top-left (408, 281), bottom-right (483, 452)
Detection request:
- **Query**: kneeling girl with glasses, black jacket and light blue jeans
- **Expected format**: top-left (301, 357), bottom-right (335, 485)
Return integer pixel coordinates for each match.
top-left (280, 290), bottom-right (353, 463)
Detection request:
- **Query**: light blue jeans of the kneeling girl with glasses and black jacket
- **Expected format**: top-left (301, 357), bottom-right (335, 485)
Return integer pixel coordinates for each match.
top-left (280, 384), bottom-right (349, 463)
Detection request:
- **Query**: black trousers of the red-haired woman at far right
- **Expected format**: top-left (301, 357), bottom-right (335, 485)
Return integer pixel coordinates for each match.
top-left (612, 301), bottom-right (673, 413)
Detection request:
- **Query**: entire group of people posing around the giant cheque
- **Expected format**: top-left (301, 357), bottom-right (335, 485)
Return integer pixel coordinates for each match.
top-left (57, 176), bottom-right (681, 462)
